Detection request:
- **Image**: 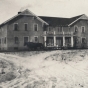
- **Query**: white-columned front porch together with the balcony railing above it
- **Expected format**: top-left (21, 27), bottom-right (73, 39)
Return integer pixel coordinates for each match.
top-left (43, 31), bottom-right (74, 47)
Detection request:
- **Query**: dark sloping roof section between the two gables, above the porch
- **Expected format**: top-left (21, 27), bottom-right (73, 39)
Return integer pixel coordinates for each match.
top-left (39, 14), bottom-right (84, 26)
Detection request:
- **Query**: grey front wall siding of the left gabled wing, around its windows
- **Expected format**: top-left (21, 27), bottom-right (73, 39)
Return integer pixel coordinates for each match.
top-left (7, 16), bottom-right (43, 50)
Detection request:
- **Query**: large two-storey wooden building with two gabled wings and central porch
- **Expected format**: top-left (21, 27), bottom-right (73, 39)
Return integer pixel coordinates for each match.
top-left (0, 9), bottom-right (88, 50)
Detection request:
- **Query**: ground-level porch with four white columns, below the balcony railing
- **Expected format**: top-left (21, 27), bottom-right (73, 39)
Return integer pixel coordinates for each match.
top-left (44, 36), bottom-right (73, 48)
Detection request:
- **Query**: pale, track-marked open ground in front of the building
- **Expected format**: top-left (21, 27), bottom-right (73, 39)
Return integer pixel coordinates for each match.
top-left (0, 50), bottom-right (88, 88)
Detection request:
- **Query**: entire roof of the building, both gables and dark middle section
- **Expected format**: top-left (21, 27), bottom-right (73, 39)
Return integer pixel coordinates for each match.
top-left (0, 9), bottom-right (88, 26)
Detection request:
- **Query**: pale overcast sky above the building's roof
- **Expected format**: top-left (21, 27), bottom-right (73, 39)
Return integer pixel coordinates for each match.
top-left (0, 0), bottom-right (88, 23)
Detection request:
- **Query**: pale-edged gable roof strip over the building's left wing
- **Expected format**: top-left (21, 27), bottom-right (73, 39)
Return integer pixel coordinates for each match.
top-left (0, 9), bottom-right (48, 26)
